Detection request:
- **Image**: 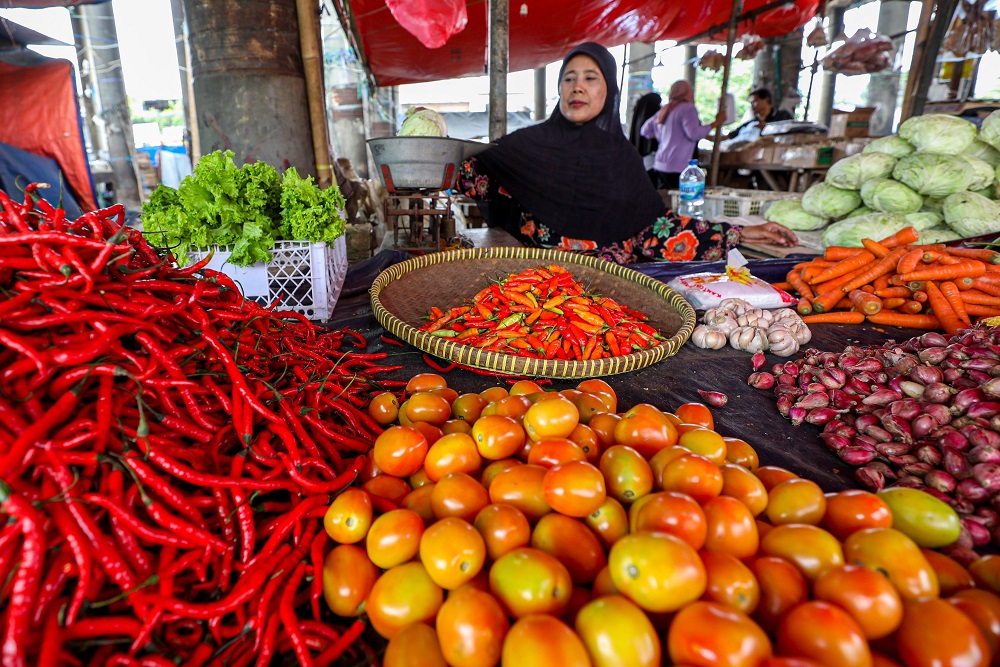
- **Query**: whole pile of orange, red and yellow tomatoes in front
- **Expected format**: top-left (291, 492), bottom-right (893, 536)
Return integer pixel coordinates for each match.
top-left (322, 374), bottom-right (1000, 667)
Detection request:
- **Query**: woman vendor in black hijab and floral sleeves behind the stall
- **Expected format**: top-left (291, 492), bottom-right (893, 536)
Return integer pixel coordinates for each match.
top-left (458, 42), bottom-right (797, 264)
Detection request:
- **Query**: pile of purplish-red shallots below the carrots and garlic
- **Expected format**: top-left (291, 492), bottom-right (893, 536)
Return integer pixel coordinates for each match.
top-left (748, 326), bottom-right (1000, 549)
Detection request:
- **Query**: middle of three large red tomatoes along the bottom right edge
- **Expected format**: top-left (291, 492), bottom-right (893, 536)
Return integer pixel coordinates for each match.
top-left (777, 600), bottom-right (872, 667)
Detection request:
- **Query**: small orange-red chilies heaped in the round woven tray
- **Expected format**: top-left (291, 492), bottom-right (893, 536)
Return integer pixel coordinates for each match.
top-left (420, 264), bottom-right (664, 361)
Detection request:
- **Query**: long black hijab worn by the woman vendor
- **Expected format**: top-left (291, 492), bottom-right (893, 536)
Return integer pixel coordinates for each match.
top-left (477, 42), bottom-right (666, 246)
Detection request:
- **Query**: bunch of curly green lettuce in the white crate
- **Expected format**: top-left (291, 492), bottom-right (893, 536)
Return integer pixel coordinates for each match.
top-left (142, 151), bottom-right (346, 266)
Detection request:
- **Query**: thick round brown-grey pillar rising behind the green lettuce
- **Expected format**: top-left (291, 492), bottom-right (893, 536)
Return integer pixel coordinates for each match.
top-left (184, 0), bottom-right (316, 176)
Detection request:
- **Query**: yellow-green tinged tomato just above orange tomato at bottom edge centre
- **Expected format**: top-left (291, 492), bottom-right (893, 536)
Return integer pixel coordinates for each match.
top-left (490, 547), bottom-right (573, 618)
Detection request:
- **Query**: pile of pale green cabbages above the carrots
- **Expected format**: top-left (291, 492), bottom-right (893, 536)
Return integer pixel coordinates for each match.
top-left (764, 111), bottom-right (1000, 246)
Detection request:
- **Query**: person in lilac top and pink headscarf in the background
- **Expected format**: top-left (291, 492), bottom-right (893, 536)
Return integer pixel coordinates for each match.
top-left (640, 79), bottom-right (725, 190)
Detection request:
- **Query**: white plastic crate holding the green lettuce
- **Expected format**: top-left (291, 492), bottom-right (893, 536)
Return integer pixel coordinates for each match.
top-left (188, 236), bottom-right (347, 321)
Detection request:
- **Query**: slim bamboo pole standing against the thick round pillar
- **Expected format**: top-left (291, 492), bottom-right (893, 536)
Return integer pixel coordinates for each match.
top-left (295, 0), bottom-right (333, 188)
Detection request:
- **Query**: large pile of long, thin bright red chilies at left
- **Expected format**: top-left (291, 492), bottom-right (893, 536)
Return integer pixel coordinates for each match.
top-left (0, 185), bottom-right (401, 667)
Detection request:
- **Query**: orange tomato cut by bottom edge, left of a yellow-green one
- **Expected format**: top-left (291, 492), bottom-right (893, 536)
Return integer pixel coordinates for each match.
top-left (500, 614), bottom-right (591, 667)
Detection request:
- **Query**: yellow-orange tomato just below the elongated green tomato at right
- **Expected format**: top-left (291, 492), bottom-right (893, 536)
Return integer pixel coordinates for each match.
top-left (840, 528), bottom-right (940, 601)
